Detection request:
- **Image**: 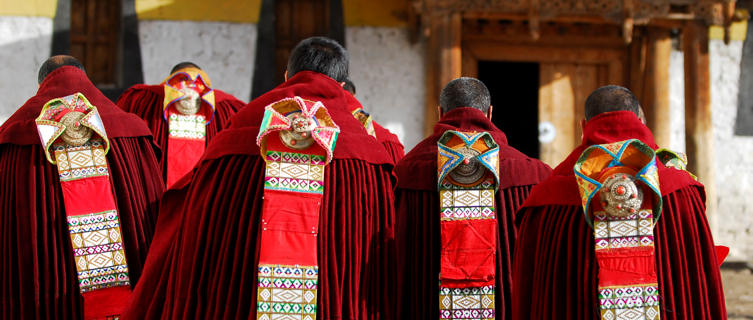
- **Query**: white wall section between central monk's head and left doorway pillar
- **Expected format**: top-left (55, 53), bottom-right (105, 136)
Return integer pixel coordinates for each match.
top-left (345, 27), bottom-right (426, 152)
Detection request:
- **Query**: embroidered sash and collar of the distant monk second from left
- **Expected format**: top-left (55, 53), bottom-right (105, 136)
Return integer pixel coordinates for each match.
top-left (163, 68), bottom-right (214, 188)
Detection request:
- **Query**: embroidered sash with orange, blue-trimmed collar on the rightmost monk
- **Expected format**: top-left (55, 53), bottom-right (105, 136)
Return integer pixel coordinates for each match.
top-left (573, 139), bottom-right (662, 320)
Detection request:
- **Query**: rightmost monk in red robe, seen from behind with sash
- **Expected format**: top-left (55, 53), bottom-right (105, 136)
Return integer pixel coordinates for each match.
top-left (513, 86), bottom-right (727, 319)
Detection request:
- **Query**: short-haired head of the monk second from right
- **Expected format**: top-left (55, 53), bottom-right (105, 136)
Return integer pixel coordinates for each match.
top-left (439, 77), bottom-right (491, 113)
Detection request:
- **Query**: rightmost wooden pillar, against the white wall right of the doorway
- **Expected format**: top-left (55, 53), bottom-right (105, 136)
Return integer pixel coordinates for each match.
top-left (682, 21), bottom-right (717, 231)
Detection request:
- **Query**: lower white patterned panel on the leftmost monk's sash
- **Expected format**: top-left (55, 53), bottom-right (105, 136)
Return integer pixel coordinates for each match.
top-left (67, 210), bottom-right (129, 293)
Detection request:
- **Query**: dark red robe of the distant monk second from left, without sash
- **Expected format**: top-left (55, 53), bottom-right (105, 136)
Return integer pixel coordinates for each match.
top-left (117, 84), bottom-right (245, 181)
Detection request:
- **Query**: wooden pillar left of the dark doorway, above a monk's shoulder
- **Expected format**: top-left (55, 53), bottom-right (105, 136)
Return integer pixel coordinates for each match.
top-left (424, 12), bottom-right (462, 136)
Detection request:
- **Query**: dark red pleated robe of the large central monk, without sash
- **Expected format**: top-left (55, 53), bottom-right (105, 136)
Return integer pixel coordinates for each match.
top-left (125, 72), bottom-right (395, 319)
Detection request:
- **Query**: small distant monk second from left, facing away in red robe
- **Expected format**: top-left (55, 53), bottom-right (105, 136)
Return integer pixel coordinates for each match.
top-left (117, 62), bottom-right (245, 187)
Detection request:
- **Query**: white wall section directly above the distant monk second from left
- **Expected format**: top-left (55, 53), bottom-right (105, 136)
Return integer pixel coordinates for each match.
top-left (139, 20), bottom-right (256, 101)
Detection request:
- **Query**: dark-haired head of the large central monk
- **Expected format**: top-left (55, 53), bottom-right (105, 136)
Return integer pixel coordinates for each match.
top-left (288, 37), bottom-right (348, 82)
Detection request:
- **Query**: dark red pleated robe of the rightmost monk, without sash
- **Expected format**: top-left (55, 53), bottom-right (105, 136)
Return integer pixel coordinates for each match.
top-left (513, 111), bottom-right (727, 319)
